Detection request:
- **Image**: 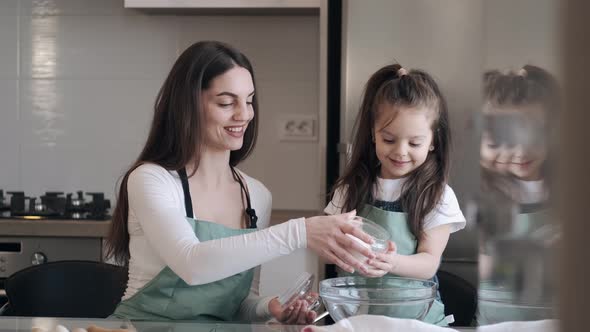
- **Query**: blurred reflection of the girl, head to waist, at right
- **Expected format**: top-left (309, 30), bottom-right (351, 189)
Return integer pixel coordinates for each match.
top-left (479, 65), bottom-right (559, 323)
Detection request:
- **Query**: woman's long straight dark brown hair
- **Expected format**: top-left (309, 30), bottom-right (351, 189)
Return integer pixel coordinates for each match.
top-left (106, 41), bottom-right (258, 265)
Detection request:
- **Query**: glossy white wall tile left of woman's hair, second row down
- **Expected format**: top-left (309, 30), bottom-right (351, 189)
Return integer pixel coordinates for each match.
top-left (20, 80), bottom-right (161, 146)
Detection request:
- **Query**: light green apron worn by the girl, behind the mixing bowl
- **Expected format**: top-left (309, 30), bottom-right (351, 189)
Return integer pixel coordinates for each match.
top-left (339, 204), bottom-right (448, 326)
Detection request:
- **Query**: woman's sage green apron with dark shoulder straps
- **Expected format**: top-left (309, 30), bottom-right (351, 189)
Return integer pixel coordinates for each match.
top-left (112, 169), bottom-right (256, 321)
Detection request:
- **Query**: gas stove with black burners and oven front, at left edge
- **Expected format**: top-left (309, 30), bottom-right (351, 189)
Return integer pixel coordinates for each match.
top-left (0, 190), bottom-right (110, 303)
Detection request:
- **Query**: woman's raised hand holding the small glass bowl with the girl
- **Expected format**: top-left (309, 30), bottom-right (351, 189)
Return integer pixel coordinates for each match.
top-left (305, 211), bottom-right (375, 273)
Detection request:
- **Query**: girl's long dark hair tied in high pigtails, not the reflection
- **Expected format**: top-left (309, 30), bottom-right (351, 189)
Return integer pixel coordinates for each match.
top-left (332, 64), bottom-right (451, 238)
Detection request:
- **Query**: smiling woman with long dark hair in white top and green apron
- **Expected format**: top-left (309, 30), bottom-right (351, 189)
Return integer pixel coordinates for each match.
top-left (108, 41), bottom-right (374, 324)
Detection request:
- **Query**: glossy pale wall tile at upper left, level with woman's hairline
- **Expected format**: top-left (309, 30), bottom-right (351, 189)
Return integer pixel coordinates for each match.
top-left (21, 16), bottom-right (177, 79)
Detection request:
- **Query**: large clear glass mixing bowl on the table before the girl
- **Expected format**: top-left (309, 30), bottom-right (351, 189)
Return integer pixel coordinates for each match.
top-left (320, 276), bottom-right (436, 321)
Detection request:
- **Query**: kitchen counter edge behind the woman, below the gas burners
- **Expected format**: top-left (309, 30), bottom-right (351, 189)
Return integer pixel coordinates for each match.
top-left (0, 210), bottom-right (319, 238)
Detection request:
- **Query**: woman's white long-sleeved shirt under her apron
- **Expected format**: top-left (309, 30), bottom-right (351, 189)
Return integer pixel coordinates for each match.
top-left (123, 164), bottom-right (307, 321)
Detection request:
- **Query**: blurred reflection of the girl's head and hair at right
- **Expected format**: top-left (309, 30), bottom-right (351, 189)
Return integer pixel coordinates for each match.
top-left (480, 65), bottom-right (558, 212)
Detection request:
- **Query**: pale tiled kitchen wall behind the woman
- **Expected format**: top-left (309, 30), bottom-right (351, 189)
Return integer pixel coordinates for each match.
top-left (0, 0), bottom-right (321, 210)
